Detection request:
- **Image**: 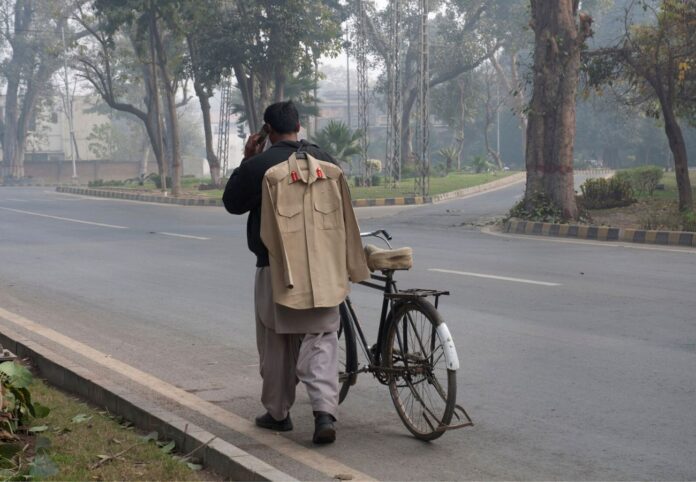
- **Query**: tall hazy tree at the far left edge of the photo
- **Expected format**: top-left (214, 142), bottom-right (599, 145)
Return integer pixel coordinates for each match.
top-left (0, 0), bottom-right (83, 178)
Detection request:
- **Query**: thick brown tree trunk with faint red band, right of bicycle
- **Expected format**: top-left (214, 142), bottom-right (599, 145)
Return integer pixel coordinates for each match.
top-left (525, 0), bottom-right (592, 219)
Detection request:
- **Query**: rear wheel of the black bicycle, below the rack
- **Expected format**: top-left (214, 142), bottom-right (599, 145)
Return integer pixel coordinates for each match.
top-left (382, 298), bottom-right (457, 441)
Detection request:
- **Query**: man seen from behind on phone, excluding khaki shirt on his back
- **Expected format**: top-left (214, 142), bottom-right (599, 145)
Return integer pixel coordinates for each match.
top-left (222, 101), bottom-right (340, 443)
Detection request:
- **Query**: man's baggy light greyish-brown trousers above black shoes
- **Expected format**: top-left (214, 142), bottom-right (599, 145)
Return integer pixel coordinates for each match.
top-left (254, 268), bottom-right (338, 420)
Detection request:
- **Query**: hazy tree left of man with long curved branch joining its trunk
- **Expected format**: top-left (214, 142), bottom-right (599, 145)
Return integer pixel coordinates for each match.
top-left (76, 0), bottom-right (188, 196)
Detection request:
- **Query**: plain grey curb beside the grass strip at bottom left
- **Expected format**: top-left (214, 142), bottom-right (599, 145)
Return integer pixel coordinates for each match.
top-left (0, 327), bottom-right (296, 481)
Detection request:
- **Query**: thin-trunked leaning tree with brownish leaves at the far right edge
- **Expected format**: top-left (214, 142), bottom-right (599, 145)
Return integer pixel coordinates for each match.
top-left (588, 0), bottom-right (696, 211)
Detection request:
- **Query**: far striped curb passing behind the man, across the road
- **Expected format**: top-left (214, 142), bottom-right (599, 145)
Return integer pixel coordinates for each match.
top-left (56, 172), bottom-right (526, 208)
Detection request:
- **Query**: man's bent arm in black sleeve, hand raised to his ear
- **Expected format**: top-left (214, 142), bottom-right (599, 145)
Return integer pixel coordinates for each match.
top-left (222, 134), bottom-right (263, 214)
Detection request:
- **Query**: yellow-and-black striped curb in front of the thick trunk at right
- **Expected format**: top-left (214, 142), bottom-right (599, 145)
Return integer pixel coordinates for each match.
top-left (503, 220), bottom-right (696, 247)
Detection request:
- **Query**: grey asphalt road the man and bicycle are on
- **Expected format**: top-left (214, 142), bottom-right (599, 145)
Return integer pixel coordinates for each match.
top-left (0, 185), bottom-right (696, 480)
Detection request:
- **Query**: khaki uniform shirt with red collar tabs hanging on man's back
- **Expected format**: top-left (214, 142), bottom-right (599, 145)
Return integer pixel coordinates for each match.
top-left (261, 153), bottom-right (370, 309)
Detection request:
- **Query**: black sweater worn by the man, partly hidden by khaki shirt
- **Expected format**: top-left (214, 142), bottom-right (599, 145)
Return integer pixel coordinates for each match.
top-left (222, 140), bottom-right (336, 267)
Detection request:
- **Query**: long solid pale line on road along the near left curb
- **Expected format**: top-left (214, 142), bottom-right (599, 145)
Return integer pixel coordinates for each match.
top-left (0, 308), bottom-right (375, 480)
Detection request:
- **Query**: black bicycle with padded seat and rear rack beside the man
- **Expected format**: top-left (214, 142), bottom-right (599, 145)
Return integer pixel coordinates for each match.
top-left (338, 229), bottom-right (473, 441)
